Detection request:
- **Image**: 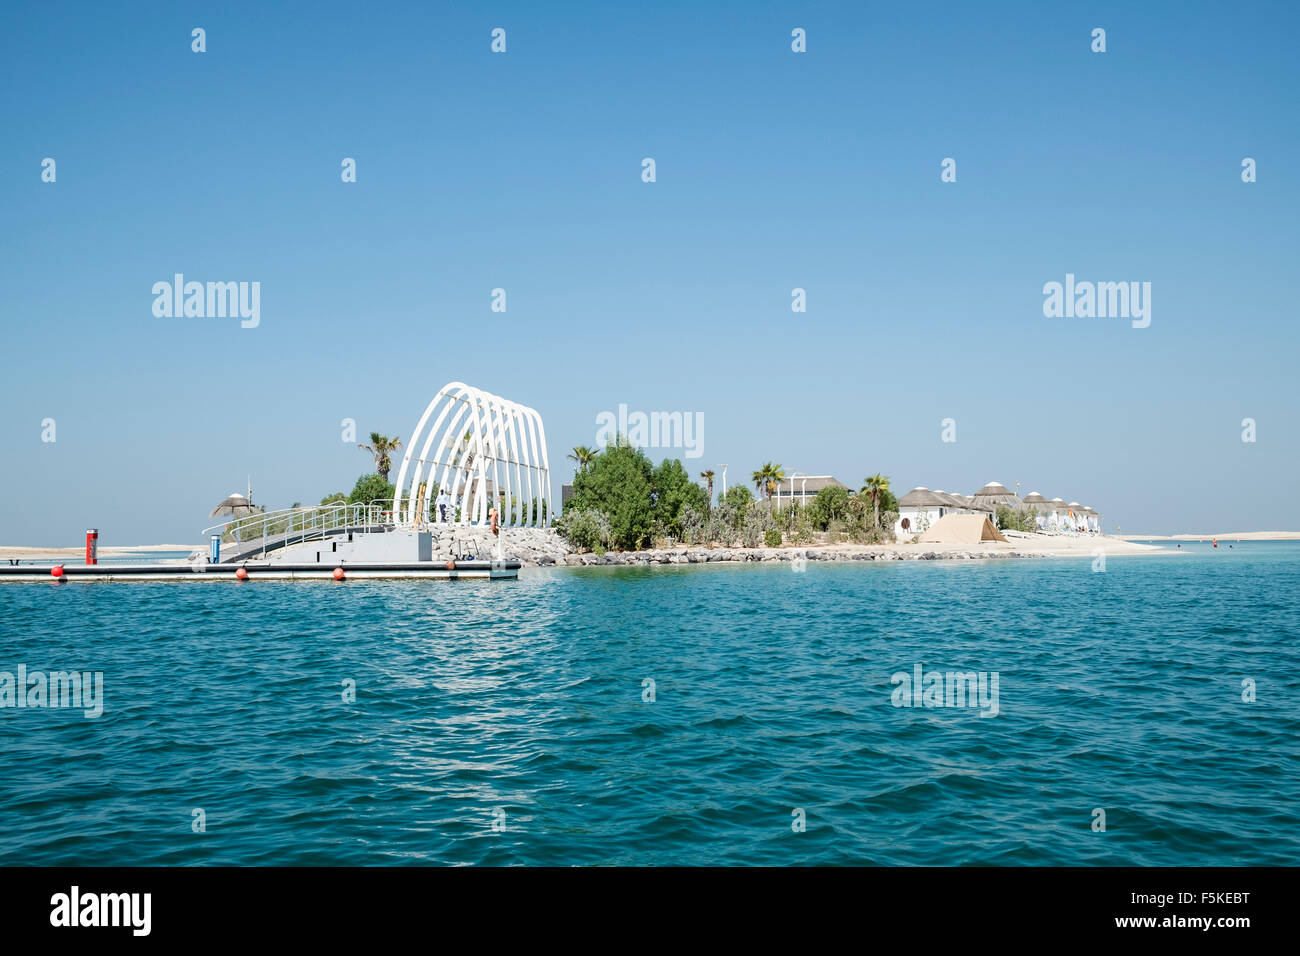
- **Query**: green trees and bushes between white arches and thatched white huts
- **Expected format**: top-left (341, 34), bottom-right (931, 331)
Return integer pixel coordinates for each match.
top-left (555, 436), bottom-right (898, 553)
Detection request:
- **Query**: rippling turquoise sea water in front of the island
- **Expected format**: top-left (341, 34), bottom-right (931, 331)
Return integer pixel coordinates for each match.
top-left (0, 544), bottom-right (1300, 865)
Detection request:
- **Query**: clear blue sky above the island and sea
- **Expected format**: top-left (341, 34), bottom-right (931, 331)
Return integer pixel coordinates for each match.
top-left (0, 3), bottom-right (1300, 545)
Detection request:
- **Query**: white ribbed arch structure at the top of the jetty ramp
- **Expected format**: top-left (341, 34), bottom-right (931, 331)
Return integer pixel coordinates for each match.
top-left (393, 381), bottom-right (551, 528)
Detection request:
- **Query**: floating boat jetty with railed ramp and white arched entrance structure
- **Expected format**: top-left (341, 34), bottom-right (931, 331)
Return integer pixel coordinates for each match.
top-left (0, 382), bottom-right (551, 581)
